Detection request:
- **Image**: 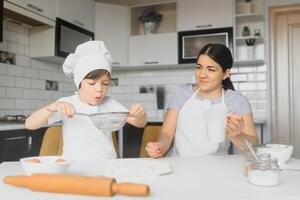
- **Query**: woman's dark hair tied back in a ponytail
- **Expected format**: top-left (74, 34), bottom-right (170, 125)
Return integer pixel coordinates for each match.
top-left (197, 43), bottom-right (234, 90)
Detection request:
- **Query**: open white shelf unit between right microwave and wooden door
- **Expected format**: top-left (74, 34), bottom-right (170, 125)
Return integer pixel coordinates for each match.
top-left (235, 0), bottom-right (265, 65)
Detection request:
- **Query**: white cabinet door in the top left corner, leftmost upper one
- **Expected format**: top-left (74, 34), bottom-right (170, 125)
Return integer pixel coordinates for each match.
top-left (8, 0), bottom-right (57, 20)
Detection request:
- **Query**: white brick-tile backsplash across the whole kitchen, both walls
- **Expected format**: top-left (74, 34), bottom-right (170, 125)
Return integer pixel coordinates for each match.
top-left (0, 20), bottom-right (268, 119)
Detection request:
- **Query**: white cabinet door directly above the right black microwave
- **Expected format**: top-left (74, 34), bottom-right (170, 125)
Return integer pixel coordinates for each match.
top-left (177, 0), bottom-right (234, 31)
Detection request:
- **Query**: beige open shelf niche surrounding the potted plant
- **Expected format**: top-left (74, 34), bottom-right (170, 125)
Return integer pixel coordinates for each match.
top-left (130, 2), bottom-right (177, 36)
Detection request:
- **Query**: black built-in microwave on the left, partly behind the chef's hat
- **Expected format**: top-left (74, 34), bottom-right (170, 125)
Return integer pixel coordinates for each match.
top-left (55, 18), bottom-right (94, 58)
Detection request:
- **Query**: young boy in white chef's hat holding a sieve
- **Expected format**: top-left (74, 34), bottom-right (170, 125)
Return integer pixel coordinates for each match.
top-left (25, 41), bottom-right (146, 159)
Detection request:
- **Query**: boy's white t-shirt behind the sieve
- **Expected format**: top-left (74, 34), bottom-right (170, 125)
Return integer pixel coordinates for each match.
top-left (48, 95), bottom-right (128, 159)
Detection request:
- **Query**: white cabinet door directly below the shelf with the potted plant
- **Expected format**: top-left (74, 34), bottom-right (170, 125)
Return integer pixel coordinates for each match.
top-left (129, 33), bottom-right (178, 66)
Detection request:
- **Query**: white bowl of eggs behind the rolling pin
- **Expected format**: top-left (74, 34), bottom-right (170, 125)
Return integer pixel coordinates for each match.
top-left (20, 156), bottom-right (71, 176)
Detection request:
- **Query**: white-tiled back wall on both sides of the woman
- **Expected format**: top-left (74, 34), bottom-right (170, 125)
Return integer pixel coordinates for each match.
top-left (111, 65), bottom-right (267, 119)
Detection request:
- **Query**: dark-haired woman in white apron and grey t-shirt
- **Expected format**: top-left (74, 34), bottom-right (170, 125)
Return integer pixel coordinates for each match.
top-left (146, 44), bottom-right (257, 158)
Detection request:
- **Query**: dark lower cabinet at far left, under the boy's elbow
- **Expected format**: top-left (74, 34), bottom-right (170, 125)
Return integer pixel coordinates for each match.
top-left (0, 128), bottom-right (46, 162)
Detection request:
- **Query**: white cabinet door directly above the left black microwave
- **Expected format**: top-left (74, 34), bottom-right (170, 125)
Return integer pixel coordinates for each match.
top-left (56, 0), bottom-right (95, 32)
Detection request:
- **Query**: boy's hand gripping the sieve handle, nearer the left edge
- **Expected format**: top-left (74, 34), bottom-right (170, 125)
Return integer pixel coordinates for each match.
top-left (47, 101), bottom-right (76, 117)
